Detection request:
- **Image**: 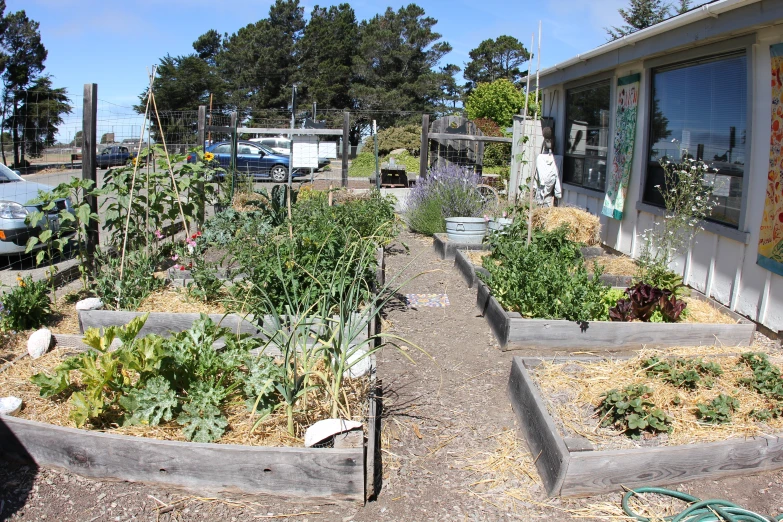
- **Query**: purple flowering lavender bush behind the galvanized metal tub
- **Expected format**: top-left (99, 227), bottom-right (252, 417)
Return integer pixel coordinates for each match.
top-left (405, 164), bottom-right (486, 234)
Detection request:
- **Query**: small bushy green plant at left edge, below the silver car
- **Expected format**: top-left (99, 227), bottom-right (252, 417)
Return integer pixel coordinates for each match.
top-left (0, 276), bottom-right (52, 331)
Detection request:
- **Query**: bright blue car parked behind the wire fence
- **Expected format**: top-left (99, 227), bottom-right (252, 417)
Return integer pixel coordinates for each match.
top-left (193, 141), bottom-right (308, 183)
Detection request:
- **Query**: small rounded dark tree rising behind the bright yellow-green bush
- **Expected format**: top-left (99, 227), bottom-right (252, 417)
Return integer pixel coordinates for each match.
top-left (465, 35), bottom-right (530, 89)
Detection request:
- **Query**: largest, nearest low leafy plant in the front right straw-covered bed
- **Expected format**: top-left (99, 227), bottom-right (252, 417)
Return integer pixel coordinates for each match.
top-left (596, 384), bottom-right (672, 439)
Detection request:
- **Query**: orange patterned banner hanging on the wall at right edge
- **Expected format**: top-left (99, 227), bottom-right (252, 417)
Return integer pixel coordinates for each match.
top-left (757, 44), bottom-right (783, 275)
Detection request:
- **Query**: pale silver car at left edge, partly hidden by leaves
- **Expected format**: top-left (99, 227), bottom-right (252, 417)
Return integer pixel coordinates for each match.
top-left (0, 163), bottom-right (73, 256)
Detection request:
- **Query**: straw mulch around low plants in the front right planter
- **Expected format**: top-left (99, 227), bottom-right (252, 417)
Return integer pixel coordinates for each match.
top-left (531, 344), bottom-right (783, 449)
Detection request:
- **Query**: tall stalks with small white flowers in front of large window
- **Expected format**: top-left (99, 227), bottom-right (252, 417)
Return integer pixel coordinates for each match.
top-left (639, 154), bottom-right (717, 284)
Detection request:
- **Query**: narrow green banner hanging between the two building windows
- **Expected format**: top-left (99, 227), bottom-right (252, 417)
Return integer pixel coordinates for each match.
top-left (601, 74), bottom-right (641, 220)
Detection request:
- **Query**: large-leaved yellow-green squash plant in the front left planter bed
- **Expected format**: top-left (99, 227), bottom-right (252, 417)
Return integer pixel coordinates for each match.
top-left (31, 314), bottom-right (260, 442)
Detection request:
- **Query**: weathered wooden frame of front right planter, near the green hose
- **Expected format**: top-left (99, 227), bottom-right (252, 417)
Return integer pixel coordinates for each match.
top-left (508, 357), bottom-right (783, 497)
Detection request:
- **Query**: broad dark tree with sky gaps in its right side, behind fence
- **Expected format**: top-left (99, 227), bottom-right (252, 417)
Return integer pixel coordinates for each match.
top-left (351, 4), bottom-right (451, 127)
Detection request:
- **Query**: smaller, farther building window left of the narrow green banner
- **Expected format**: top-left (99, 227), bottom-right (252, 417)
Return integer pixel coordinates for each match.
top-left (563, 80), bottom-right (611, 191)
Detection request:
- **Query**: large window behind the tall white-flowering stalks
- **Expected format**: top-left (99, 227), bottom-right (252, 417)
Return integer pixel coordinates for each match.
top-left (642, 51), bottom-right (748, 228)
